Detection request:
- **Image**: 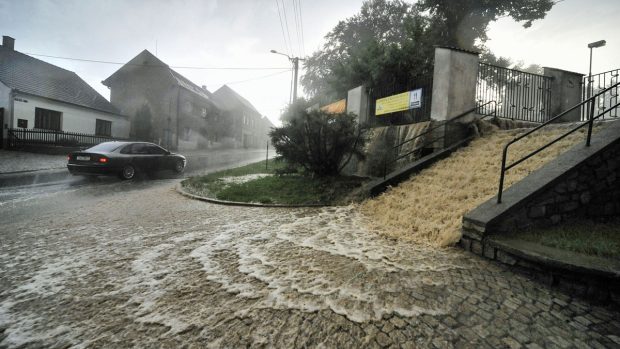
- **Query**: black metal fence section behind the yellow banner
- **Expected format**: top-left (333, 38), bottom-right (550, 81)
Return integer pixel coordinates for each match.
top-left (368, 73), bottom-right (433, 127)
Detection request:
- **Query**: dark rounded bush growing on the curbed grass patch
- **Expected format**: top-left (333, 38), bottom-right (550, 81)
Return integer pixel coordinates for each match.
top-left (269, 100), bottom-right (366, 177)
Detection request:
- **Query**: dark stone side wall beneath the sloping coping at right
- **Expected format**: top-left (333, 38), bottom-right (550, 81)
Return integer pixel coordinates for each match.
top-left (492, 141), bottom-right (620, 232)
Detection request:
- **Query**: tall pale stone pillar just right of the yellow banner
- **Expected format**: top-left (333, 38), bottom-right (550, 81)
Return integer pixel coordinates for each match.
top-left (431, 47), bottom-right (479, 121)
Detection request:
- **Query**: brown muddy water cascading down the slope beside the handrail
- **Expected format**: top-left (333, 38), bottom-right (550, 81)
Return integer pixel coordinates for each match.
top-left (361, 123), bottom-right (598, 246)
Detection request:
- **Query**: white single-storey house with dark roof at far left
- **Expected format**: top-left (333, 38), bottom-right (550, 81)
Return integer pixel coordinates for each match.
top-left (0, 36), bottom-right (129, 145)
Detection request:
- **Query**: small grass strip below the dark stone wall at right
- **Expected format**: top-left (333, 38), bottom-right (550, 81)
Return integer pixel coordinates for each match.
top-left (514, 220), bottom-right (620, 258)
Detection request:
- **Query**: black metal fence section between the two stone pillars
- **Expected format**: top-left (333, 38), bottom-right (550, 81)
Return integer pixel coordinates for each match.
top-left (476, 63), bottom-right (551, 122)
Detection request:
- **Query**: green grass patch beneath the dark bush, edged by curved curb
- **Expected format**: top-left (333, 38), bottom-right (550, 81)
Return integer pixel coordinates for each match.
top-left (182, 160), bottom-right (363, 205)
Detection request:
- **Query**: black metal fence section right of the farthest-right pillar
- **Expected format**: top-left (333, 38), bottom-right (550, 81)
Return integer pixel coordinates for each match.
top-left (581, 69), bottom-right (620, 121)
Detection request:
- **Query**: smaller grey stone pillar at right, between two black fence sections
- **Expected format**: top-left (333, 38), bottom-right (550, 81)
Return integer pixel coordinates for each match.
top-left (543, 67), bottom-right (584, 122)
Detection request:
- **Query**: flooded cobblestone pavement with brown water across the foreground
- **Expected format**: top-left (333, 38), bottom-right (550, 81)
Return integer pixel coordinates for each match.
top-left (0, 180), bottom-right (620, 348)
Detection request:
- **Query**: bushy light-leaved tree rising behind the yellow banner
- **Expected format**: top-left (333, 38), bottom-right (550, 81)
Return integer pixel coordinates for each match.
top-left (301, 0), bottom-right (436, 100)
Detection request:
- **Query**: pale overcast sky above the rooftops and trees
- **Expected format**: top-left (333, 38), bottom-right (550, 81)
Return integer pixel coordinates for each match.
top-left (0, 0), bottom-right (620, 124)
